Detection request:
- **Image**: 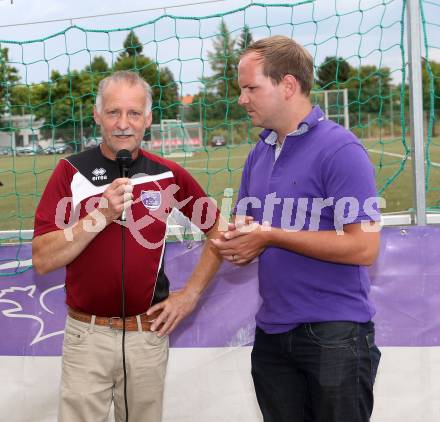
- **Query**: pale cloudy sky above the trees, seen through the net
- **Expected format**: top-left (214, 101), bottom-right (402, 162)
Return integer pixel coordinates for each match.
top-left (0, 0), bottom-right (440, 95)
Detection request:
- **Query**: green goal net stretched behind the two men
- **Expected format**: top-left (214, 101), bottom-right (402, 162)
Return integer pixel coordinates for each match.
top-left (0, 0), bottom-right (440, 270)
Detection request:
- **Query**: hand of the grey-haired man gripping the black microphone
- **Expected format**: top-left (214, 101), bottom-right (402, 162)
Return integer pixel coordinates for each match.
top-left (98, 177), bottom-right (133, 224)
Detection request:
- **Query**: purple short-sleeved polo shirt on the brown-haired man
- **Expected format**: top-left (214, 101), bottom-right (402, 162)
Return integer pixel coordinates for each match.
top-left (235, 106), bottom-right (380, 333)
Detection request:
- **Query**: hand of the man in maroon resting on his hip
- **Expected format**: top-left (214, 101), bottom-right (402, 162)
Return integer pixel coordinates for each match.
top-left (147, 288), bottom-right (200, 337)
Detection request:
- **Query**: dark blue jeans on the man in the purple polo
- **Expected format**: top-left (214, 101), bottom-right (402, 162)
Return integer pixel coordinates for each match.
top-left (252, 321), bottom-right (380, 422)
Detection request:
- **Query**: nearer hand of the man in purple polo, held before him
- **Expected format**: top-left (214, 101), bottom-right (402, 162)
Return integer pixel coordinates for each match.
top-left (211, 219), bottom-right (270, 265)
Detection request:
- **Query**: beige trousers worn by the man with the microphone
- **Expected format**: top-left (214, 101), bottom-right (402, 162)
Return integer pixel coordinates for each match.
top-left (58, 316), bottom-right (168, 422)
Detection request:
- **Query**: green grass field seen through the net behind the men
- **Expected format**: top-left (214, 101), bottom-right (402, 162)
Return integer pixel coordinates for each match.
top-left (0, 139), bottom-right (440, 230)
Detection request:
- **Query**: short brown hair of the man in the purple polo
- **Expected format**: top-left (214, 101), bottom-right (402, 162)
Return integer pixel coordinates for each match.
top-left (242, 35), bottom-right (314, 96)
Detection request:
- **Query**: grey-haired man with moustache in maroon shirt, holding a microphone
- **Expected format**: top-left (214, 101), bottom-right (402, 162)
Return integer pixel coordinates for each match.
top-left (32, 72), bottom-right (221, 422)
